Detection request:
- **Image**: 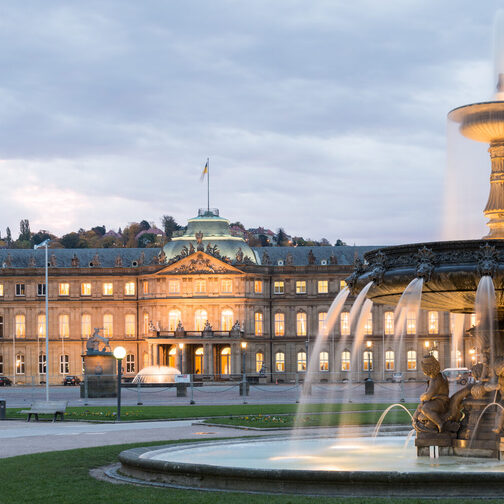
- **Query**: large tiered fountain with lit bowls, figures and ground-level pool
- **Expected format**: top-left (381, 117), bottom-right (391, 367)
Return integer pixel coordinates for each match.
top-left (111, 14), bottom-right (504, 497)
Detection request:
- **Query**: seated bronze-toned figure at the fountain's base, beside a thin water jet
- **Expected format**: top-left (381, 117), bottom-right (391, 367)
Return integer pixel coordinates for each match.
top-left (412, 355), bottom-right (450, 432)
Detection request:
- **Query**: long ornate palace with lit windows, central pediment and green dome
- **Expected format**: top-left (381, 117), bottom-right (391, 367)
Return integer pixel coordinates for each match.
top-left (0, 210), bottom-right (469, 383)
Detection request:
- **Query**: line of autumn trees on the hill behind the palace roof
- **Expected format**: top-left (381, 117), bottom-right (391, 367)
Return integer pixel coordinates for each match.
top-left (0, 215), bottom-right (346, 249)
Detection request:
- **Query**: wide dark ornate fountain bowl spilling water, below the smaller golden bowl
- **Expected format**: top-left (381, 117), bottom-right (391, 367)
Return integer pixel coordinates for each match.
top-left (347, 240), bottom-right (504, 313)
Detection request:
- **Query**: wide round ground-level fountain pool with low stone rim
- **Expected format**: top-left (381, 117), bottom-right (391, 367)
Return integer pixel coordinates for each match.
top-left (119, 436), bottom-right (504, 497)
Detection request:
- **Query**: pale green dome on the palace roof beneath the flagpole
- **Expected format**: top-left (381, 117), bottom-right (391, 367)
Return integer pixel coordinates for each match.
top-left (163, 208), bottom-right (260, 264)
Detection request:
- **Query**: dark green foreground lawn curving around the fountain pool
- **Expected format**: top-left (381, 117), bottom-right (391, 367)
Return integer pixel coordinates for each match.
top-left (0, 441), bottom-right (502, 504)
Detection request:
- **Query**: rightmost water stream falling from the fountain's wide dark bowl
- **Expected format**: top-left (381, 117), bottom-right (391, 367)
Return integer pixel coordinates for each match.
top-left (475, 275), bottom-right (496, 367)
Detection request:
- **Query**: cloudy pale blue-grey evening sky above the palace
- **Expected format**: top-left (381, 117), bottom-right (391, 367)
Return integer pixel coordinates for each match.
top-left (0, 0), bottom-right (500, 245)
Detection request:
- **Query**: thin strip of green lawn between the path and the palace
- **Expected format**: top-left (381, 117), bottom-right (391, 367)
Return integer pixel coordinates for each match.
top-left (7, 403), bottom-right (416, 422)
